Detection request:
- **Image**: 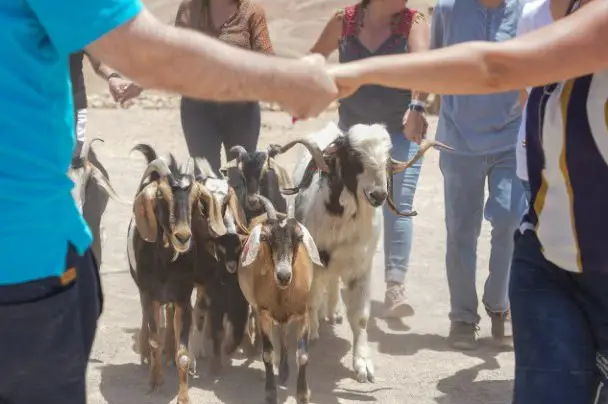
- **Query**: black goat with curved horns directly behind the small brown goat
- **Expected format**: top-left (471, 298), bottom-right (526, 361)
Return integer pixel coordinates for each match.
top-left (221, 145), bottom-right (293, 223)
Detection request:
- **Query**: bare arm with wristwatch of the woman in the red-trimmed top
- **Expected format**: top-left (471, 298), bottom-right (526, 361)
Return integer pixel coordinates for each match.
top-left (403, 12), bottom-right (430, 144)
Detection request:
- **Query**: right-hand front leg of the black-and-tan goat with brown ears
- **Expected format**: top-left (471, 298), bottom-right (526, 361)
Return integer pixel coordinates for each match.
top-left (173, 301), bottom-right (192, 404)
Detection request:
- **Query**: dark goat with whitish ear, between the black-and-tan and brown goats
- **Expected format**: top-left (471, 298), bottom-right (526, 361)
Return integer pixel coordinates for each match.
top-left (185, 159), bottom-right (249, 375)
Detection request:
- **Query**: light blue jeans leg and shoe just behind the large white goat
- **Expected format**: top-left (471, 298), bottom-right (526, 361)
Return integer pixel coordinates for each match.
top-left (383, 134), bottom-right (422, 317)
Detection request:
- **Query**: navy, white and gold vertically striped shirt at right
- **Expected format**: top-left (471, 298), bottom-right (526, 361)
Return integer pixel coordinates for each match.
top-left (521, 70), bottom-right (608, 274)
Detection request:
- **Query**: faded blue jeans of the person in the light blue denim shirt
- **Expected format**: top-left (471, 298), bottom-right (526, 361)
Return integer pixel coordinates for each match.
top-left (439, 150), bottom-right (523, 324)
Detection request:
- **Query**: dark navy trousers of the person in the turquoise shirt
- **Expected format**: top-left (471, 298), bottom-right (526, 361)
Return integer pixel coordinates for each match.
top-left (0, 246), bottom-right (103, 404)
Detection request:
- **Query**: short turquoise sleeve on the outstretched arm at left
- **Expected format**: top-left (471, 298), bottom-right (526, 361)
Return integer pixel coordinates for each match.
top-left (26, 0), bottom-right (143, 56)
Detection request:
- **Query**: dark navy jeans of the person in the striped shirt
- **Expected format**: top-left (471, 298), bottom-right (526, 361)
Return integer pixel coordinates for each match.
top-left (509, 231), bottom-right (608, 404)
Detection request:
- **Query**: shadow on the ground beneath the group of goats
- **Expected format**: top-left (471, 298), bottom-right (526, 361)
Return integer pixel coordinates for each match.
top-left (100, 324), bottom-right (378, 404)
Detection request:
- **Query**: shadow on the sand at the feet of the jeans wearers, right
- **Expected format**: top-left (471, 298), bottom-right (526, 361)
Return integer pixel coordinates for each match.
top-left (368, 301), bottom-right (513, 404)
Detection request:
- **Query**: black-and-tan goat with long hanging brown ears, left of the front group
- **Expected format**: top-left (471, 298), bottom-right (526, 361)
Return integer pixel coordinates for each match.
top-left (127, 144), bottom-right (226, 404)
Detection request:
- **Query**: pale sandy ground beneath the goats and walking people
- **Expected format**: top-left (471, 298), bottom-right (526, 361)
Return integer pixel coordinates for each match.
top-left (83, 105), bottom-right (513, 404)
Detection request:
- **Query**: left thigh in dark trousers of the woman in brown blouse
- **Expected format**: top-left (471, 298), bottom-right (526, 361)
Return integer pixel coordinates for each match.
top-left (180, 98), bottom-right (222, 171)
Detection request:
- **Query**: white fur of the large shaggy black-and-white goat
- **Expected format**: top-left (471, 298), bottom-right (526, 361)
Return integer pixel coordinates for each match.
top-left (293, 122), bottom-right (392, 382)
